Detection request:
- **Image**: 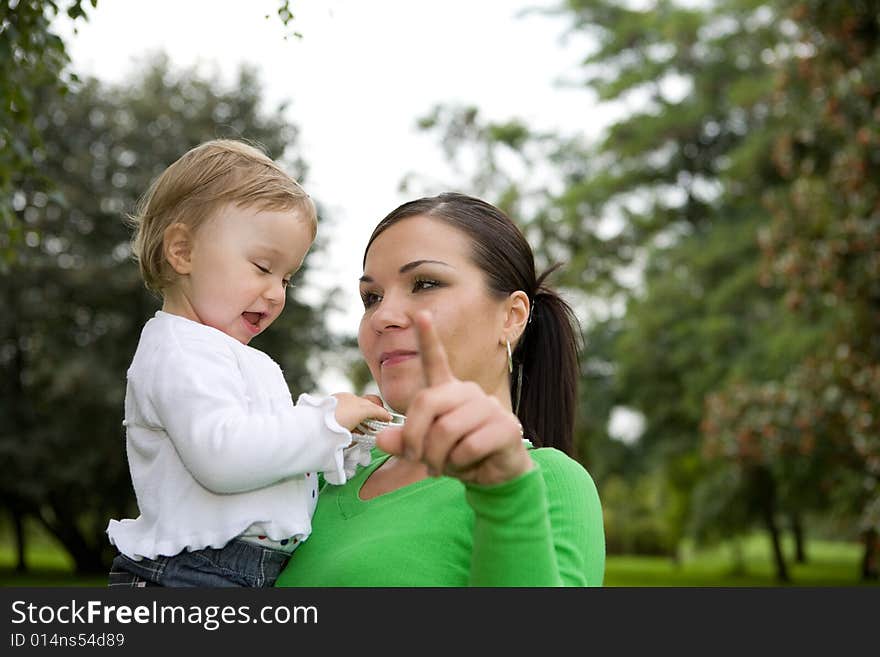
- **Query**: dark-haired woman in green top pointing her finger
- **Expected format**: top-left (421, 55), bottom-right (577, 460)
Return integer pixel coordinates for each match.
top-left (276, 194), bottom-right (605, 587)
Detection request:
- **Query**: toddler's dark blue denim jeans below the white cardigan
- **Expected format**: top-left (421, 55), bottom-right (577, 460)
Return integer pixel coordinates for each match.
top-left (108, 539), bottom-right (290, 588)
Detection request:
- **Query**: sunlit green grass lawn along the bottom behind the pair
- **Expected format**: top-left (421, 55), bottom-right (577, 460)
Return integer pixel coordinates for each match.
top-left (0, 534), bottom-right (880, 587)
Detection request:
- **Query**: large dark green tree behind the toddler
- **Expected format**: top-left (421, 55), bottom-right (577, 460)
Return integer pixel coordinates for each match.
top-left (0, 53), bottom-right (329, 572)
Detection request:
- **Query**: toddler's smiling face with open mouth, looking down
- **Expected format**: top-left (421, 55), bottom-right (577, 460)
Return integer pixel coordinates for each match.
top-left (175, 204), bottom-right (312, 344)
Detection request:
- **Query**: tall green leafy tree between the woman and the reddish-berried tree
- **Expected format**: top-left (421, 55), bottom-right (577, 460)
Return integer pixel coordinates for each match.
top-left (420, 0), bottom-right (804, 556)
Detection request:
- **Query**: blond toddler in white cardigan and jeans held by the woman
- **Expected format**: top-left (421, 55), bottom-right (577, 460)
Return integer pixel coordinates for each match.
top-left (107, 140), bottom-right (391, 587)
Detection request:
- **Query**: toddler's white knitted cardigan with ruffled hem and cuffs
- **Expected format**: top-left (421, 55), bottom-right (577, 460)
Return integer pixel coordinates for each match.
top-left (107, 311), bottom-right (354, 559)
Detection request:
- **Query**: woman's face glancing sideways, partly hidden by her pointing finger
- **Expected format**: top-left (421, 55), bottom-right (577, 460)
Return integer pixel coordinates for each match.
top-left (358, 215), bottom-right (510, 413)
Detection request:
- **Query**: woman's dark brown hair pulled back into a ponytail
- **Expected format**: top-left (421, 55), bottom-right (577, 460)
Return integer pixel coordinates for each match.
top-left (364, 193), bottom-right (580, 454)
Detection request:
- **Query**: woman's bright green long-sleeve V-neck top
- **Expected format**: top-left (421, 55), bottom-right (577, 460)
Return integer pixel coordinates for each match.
top-left (275, 448), bottom-right (605, 587)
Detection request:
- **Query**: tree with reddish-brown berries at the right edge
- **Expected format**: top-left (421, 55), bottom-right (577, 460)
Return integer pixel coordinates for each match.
top-left (708, 0), bottom-right (880, 579)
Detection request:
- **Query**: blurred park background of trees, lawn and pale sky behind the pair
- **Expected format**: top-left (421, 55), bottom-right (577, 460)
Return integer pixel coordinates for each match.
top-left (0, 0), bottom-right (880, 586)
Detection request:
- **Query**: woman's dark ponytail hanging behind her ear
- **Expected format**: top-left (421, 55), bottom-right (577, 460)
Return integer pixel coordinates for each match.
top-left (510, 265), bottom-right (580, 455)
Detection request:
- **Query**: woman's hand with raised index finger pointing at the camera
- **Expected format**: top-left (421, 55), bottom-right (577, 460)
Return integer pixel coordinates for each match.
top-left (376, 312), bottom-right (534, 485)
